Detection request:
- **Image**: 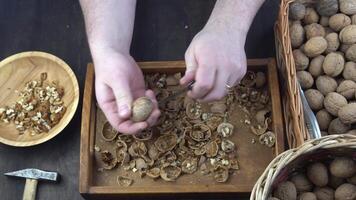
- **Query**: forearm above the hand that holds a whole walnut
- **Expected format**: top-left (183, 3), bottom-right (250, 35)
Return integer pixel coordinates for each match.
top-left (80, 0), bottom-right (136, 56)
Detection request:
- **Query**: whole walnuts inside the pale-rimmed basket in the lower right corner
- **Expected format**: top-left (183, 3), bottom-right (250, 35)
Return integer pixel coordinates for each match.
top-left (268, 157), bottom-right (356, 200)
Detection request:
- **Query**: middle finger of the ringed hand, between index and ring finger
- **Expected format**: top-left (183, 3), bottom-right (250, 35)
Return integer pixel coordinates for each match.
top-left (199, 72), bottom-right (229, 102)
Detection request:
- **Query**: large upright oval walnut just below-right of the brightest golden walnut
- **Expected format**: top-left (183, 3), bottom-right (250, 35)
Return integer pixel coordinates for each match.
top-left (323, 52), bottom-right (345, 77)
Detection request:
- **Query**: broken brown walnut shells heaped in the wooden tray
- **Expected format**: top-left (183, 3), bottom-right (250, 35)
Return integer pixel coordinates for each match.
top-left (95, 71), bottom-right (276, 187)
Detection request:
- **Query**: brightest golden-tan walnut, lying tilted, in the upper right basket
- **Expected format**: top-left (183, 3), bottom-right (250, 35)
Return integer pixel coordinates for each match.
top-left (304, 36), bottom-right (328, 58)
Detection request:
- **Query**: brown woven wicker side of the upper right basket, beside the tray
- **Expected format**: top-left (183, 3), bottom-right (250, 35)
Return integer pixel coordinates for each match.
top-left (275, 0), bottom-right (313, 148)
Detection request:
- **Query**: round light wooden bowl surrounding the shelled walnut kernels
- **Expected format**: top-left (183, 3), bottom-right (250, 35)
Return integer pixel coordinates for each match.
top-left (0, 51), bottom-right (79, 147)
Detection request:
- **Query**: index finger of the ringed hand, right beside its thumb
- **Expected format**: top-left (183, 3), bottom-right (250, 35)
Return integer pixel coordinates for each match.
top-left (188, 64), bottom-right (216, 99)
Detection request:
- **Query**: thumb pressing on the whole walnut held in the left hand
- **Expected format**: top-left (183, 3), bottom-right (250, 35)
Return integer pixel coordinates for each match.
top-left (112, 78), bottom-right (132, 119)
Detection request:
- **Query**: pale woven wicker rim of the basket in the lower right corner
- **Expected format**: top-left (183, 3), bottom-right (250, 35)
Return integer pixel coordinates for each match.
top-left (250, 134), bottom-right (356, 200)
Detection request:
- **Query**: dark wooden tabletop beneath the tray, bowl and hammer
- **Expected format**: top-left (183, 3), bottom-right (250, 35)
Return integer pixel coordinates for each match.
top-left (0, 0), bottom-right (278, 200)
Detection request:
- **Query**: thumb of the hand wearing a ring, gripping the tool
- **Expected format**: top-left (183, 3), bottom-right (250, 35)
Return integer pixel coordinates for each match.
top-left (180, 48), bottom-right (198, 85)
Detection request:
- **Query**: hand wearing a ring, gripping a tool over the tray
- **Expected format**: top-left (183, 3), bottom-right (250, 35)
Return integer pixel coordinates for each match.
top-left (180, 24), bottom-right (246, 102)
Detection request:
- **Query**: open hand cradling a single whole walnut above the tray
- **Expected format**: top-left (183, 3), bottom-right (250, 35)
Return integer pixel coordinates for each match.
top-left (93, 51), bottom-right (160, 134)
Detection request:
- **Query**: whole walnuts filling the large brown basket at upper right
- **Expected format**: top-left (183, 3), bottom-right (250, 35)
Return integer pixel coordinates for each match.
top-left (289, 0), bottom-right (356, 135)
